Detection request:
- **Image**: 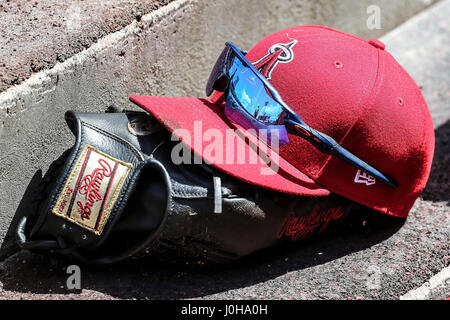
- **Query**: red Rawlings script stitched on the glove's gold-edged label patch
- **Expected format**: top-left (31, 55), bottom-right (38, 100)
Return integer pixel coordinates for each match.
top-left (77, 159), bottom-right (112, 220)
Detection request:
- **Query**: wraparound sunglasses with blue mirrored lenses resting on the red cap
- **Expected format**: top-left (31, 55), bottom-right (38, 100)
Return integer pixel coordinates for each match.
top-left (206, 42), bottom-right (398, 188)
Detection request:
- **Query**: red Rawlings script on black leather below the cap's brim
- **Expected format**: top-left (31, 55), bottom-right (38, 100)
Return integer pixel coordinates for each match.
top-left (277, 205), bottom-right (344, 241)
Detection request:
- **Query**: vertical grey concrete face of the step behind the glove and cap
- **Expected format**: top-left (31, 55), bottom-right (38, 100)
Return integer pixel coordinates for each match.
top-left (0, 0), bottom-right (442, 247)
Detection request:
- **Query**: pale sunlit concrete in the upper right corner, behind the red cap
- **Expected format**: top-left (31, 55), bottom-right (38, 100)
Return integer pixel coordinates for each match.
top-left (382, 1), bottom-right (450, 128)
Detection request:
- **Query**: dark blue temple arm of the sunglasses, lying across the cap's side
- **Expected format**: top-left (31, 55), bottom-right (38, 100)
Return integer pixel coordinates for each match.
top-left (286, 119), bottom-right (398, 188)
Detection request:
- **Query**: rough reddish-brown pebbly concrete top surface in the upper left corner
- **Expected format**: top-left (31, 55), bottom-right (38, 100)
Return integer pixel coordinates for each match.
top-left (0, 0), bottom-right (173, 92)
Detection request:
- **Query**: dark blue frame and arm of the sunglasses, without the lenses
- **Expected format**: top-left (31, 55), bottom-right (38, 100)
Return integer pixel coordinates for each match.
top-left (207, 41), bottom-right (398, 188)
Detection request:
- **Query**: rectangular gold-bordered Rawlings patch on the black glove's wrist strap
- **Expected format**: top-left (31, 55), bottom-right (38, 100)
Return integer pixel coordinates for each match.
top-left (52, 145), bottom-right (133, 235)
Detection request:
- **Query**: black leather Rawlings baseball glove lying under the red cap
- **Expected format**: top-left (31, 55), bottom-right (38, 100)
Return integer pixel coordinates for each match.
top-left (17, 112), bottom-right (352, 264)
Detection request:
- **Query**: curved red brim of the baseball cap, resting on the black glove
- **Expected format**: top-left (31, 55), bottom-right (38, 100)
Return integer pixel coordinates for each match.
top-left (130, 95), bottom-right (330, 196)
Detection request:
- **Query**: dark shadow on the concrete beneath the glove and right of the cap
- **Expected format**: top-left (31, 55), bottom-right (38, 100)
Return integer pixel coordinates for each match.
top-left (0, 121), bottom-right (444, 300)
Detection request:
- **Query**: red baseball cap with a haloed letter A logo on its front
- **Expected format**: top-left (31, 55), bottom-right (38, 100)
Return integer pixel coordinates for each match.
top-left (130, 26), bottom-right (434, 217)
